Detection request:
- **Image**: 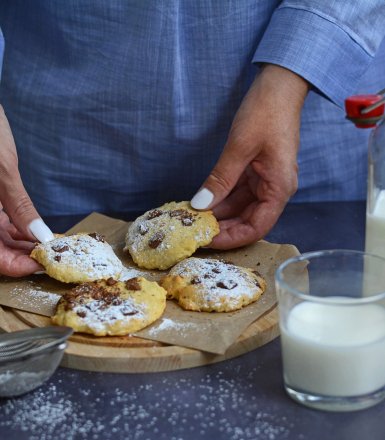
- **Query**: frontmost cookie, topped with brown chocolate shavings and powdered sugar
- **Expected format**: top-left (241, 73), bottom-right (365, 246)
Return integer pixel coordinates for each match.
top-left (52, 277), bottom-right (166, 336)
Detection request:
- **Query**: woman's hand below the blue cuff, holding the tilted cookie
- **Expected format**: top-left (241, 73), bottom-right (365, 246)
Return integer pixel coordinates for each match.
top-left (191, 65), bottom-right (309, 249)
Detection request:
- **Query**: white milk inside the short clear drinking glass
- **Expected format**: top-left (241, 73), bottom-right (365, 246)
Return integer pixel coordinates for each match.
top-left (281, 301), bottom-right (385, 397)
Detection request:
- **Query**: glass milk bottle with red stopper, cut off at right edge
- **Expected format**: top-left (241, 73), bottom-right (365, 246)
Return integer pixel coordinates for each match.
top-left (345, 95), bottom-right (385, 257)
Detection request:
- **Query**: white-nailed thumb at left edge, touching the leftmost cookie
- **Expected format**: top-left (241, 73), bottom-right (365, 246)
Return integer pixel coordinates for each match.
top-left (0, 174), bottom-right (54, 243)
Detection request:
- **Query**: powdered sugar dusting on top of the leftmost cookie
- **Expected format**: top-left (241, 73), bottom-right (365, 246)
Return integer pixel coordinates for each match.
top-left (38, 234), bottom-right (123, 281)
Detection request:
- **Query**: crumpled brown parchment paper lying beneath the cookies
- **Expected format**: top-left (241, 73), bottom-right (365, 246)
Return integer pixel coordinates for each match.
top-left (0, 213), bottom-right (299, 354)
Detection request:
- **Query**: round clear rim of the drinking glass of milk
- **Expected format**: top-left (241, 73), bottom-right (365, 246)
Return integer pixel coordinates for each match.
top-left (274, 249), bottom-right (385, 306)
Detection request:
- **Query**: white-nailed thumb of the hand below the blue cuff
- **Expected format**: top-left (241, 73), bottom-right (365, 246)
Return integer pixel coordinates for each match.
top-left (191, 142), bottom-right (250, 209)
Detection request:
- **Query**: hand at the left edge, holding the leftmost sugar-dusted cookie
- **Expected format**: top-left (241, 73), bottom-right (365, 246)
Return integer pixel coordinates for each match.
top-left (0, 105), bottom-right (54, 277)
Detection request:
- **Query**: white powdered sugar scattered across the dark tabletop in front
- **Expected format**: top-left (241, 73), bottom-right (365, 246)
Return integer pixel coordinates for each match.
top-left (0, 368), bottom-right (296, 440)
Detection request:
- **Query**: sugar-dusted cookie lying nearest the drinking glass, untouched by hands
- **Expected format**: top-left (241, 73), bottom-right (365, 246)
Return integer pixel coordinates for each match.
top-left (160, 258), bottom-right (266, 312)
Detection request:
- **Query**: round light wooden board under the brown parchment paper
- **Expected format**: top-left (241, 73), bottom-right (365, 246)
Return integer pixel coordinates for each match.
top-left (0, 307), bottom-right (279, 373)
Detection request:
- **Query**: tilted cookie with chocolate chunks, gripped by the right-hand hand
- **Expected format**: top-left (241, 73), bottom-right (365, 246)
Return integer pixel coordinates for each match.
top-left (124, 202), bottom-right (219, 269)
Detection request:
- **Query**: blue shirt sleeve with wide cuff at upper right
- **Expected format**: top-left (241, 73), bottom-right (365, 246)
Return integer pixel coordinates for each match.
top-left (253, 0), bottom-right (385, 106)
